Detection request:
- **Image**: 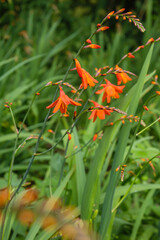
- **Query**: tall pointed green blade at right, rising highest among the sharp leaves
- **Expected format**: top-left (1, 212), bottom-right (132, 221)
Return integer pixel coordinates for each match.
top-left (100, 44), bottom-right (154, 239)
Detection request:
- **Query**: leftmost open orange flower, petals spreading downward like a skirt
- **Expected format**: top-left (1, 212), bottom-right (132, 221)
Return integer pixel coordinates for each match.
top-left (46, 86), bottom-right (81, 113)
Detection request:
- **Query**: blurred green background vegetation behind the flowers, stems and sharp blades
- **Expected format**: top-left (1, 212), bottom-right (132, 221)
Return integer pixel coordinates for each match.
top-left (0, 0), bottom-right (160, 240)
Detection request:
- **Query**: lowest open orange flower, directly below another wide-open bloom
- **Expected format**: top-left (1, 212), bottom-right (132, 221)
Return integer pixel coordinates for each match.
top-left (88, 100), bottom-right (112, 122)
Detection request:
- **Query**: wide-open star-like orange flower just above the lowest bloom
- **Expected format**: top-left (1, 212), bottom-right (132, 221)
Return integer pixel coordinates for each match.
top-left (96, 79), bottom-right (125, 103)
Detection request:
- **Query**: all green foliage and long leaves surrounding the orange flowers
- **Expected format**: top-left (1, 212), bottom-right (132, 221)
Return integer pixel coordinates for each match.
top-left (0, 0), bottom-right (160, 240)
